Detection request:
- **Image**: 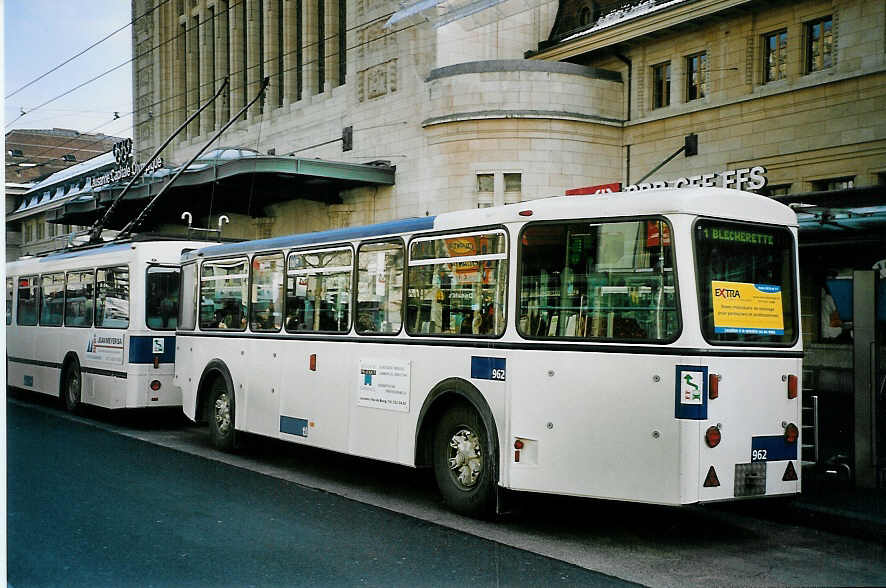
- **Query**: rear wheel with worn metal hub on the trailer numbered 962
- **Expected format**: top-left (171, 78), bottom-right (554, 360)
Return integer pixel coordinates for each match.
top-left (433, 404), bottom-right (496, 518)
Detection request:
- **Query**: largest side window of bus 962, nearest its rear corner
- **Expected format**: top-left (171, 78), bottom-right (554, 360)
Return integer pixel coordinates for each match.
top-left (517, 219), bottom-right (680, 342)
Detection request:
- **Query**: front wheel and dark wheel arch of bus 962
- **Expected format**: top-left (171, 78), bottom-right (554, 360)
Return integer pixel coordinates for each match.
top-left (195, 359), bottom-right (237, 450)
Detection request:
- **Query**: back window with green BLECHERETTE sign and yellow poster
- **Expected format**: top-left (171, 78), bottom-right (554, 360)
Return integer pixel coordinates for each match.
top-left (695, 219), bottom-right (797, 345)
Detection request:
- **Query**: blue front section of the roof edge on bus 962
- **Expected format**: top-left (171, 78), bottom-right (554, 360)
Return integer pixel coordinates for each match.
top-left (182, 216), bottom-right (436, 260)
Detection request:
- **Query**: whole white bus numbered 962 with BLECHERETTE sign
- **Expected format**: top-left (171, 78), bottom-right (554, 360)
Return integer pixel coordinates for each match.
top-left (176, 189), bottom-right (801, 516)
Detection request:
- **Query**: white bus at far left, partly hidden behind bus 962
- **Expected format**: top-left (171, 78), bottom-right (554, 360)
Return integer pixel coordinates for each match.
top-left (6, 240), bottom-right (208, 411)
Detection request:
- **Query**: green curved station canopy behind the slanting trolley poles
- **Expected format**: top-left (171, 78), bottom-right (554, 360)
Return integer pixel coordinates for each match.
top-left (47, 147), bottom-right (396, 229)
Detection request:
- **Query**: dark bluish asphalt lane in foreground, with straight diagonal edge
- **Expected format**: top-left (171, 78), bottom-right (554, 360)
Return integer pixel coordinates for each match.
top-left (7, 403), bottom-right (628, 587)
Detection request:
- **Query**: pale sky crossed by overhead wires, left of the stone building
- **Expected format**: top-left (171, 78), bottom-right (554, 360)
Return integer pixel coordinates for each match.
top-left (0, 0), bottom-right (132, 137)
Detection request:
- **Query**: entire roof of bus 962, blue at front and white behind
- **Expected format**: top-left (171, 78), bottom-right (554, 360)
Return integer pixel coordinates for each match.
top-left (182, 188), bottom-right (797, 261)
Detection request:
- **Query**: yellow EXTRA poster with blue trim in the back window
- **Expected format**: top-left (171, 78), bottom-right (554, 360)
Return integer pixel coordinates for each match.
top-left (711, 281), bottom-right (784, 335)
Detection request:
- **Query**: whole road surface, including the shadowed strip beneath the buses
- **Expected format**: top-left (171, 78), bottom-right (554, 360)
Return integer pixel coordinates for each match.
top-left (7, 396), bottom-right (886, 587)
